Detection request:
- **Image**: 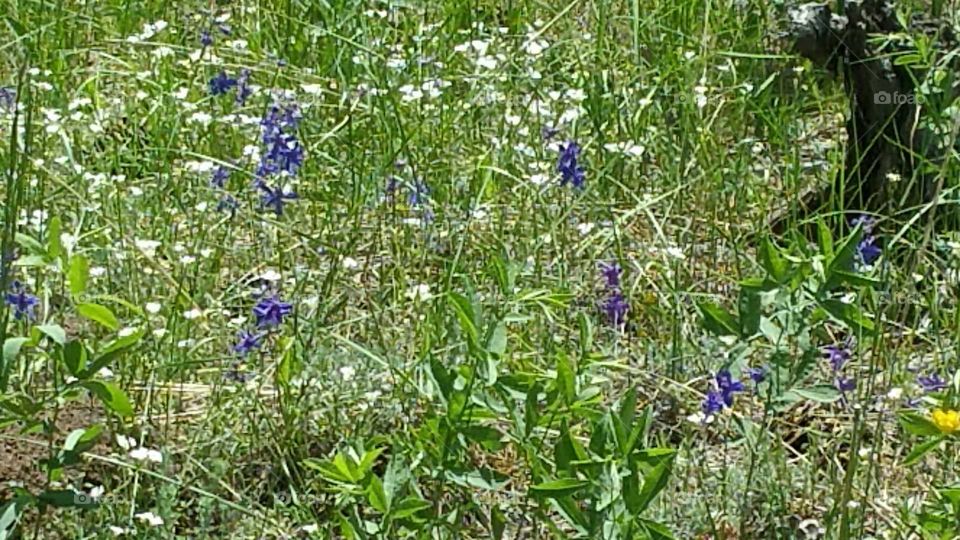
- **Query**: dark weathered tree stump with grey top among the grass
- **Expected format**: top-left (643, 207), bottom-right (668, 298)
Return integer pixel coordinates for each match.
top-left (771, 0), bottom-right (954, 233)
